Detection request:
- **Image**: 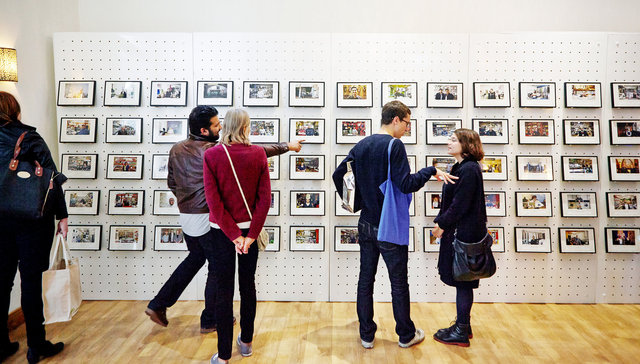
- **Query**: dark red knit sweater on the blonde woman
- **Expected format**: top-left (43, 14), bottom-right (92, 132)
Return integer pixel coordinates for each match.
top-left (204, 144), bottom-right (271, 241)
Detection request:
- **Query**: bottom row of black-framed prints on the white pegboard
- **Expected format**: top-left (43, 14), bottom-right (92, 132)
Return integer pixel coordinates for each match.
top-left (68, 225), bottom-right (640, 253)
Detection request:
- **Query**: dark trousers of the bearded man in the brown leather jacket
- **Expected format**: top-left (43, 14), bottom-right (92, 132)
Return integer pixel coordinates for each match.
top-left (148, 230), bottom-right (217, 328)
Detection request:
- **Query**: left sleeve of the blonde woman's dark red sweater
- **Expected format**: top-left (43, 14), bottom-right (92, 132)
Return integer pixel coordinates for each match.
top-left (203, 147), bottom-right (242, 241)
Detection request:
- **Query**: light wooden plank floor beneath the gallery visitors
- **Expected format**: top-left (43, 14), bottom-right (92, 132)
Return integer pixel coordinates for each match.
top-left (6, 301), bottom-right (640, 364)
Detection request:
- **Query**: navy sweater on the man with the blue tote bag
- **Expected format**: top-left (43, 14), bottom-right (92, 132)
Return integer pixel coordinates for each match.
top-left (333, 134), bottom-right (436, 227)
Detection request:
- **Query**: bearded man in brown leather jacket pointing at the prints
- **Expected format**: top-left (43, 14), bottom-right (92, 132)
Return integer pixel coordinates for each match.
top-left (145, 106), bottom-right (304, 334)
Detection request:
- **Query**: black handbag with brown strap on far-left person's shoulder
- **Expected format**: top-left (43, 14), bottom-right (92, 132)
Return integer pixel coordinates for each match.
top-left (0, 131), bottom-right (55, 220)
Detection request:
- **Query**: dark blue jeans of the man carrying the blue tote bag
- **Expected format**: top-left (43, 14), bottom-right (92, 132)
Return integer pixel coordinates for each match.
top-left (357, 221), bottom-right (416, 343)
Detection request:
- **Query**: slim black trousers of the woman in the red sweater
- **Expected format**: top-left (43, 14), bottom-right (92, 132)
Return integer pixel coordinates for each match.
top-left (211, 229), bottom-right (258, 360)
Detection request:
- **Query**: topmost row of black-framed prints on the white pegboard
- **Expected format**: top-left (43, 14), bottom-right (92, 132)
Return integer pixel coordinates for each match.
top-left (58, 80), bottom-right (640, 108)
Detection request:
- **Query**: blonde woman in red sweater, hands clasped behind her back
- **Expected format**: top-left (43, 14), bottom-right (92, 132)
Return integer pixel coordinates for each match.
top-left (204, 109), bottom-right (271, 363)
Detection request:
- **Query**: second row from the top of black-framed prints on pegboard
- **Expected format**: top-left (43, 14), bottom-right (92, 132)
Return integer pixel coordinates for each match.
top-left (59, 117), bottom-right (640, 145)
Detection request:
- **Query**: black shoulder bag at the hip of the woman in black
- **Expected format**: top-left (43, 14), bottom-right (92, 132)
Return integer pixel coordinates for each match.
top-left (453, 233), bottom-right (496, 281)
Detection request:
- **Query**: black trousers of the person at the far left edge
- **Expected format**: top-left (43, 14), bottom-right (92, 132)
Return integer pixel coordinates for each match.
top-left (0, 216), bottom-right (55, 348)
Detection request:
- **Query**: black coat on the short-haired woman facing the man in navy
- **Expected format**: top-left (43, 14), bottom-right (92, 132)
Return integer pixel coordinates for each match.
top-left (433, 159), bottom-right (487, 288)
